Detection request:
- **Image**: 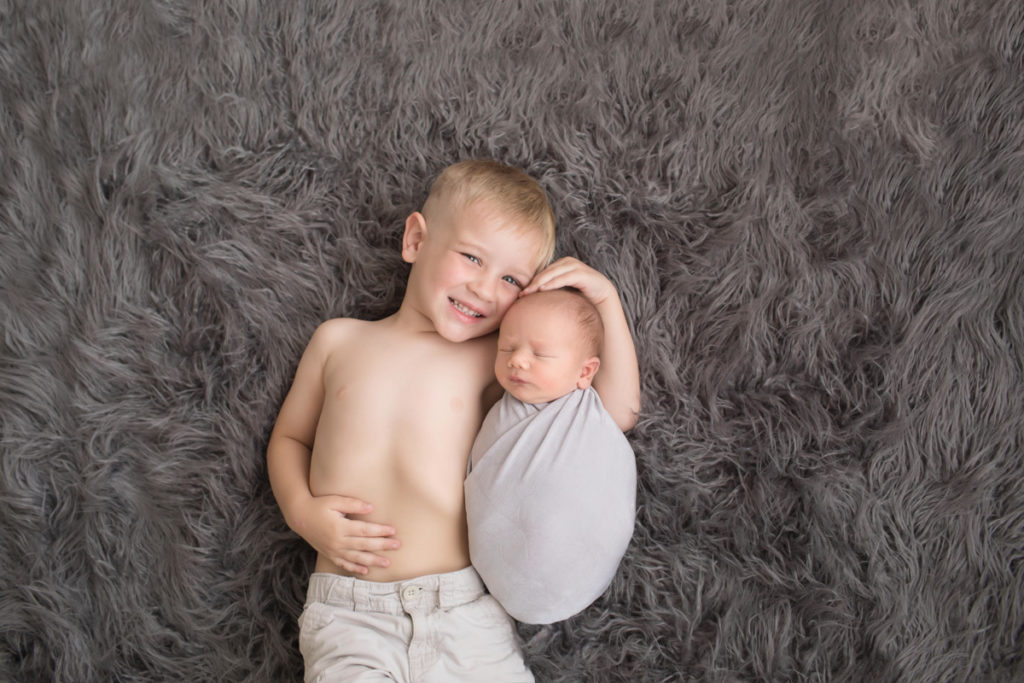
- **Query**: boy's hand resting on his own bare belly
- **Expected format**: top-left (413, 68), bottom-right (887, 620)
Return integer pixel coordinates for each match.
top-left (293, 496), bottom-right (400, 574)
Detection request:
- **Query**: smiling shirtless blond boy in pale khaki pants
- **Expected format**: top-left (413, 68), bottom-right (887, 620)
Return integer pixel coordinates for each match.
top-left (267, 162), bottom-right (639, 681)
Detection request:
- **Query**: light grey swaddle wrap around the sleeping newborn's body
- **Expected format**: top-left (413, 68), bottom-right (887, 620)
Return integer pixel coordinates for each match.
top-left (465, 388), bottom-right (636, 624)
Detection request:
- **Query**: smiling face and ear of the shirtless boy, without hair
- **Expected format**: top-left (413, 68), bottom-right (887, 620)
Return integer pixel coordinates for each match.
top-left (402, 200), bottom-right (541, 342)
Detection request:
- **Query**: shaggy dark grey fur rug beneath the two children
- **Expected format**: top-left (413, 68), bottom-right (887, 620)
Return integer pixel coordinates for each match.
top-left (0, 0), bottom-right (1024, 682)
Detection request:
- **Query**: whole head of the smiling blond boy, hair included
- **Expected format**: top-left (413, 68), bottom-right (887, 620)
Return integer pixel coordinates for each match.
top-left (401, 160), bottom-right (555, 342)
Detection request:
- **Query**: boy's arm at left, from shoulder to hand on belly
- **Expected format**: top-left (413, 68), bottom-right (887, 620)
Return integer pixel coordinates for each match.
top-left (266, 321), bottom-right (397, 573)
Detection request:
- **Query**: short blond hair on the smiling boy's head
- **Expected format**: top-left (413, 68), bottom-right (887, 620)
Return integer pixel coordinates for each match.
top-left (423, 159), bottom-right (555, 267)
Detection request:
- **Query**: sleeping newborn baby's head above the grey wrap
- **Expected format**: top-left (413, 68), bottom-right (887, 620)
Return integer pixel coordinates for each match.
top-left (495, 288), bottom-right (604, 403)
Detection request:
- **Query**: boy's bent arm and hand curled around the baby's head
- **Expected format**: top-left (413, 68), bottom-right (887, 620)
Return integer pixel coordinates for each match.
top-left (522, 257), bottom-right (640, 431)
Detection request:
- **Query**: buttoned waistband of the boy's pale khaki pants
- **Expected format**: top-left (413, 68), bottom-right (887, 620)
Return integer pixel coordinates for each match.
top-left (306, 566), bottom-right (485, 614)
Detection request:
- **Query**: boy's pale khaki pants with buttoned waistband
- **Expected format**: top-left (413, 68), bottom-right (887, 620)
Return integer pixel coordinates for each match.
top-left (299, 567), bottom-right (534, 683)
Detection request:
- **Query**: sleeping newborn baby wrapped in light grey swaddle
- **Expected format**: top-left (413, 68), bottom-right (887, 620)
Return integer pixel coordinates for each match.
top-left (465, 289), bottom-right (636, 624)
